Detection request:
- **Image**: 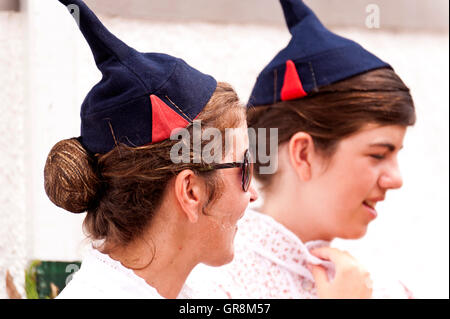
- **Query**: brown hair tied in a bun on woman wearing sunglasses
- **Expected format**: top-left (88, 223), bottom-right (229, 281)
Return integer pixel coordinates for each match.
top-left (44, 82), bottom-right (245, 246)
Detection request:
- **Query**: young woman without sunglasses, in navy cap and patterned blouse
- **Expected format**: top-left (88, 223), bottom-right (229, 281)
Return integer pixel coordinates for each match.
top-left (185, 0), bottom-right (415, 298)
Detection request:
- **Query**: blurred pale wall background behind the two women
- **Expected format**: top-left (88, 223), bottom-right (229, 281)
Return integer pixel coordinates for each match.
top-left (0, 0), bottom-right (449, 298)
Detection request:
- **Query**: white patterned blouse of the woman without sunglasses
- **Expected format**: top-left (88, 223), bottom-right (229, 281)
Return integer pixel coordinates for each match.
top-left (185, 209), bottom-right (412, 299)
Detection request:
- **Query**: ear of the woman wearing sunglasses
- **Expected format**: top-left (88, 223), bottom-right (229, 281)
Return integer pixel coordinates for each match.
top-left (175, 169), bottom-right (205, 223)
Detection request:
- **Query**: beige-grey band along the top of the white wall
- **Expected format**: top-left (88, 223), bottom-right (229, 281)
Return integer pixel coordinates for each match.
top-left (81, 0), bottom-right (449, 30)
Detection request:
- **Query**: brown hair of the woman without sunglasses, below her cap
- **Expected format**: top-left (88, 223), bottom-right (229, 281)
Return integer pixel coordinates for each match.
top-left (247, 68), bottom-right (416, 191)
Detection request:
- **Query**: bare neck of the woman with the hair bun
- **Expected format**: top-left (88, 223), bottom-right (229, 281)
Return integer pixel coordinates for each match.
top-left (106, 215), bottom-right (198, 299)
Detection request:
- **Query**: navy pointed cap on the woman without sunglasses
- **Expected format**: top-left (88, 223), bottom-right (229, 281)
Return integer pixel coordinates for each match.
top-left (248, 0), bottom-right (391, 106)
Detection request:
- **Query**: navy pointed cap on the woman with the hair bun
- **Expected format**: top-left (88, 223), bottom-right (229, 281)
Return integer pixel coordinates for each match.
top-left (59, 0), bottom-right (217, 154)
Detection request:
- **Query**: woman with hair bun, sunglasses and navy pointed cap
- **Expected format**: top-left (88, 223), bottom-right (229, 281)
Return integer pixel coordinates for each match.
top-left (44, 0), bottom-right (257, 298)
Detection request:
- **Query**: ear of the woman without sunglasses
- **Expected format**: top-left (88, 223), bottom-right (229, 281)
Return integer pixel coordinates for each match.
top-left (288, 132), bottom-right (314, 181)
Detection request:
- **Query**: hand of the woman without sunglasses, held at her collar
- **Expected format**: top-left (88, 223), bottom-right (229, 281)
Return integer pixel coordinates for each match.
top-left (308, 247), bottom-right (372, 299)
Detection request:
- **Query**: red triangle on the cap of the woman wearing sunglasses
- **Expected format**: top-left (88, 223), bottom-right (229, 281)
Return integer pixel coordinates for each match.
top-left (150, 95), bottom-right (189, 143)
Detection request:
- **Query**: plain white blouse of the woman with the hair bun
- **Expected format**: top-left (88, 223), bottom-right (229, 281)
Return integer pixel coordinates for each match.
top-left (57, 248), bottom-right (163, 299)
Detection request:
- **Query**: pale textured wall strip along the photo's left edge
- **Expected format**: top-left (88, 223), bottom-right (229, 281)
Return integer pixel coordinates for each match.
top-left (0, 12), bottom-right (29, 298)
